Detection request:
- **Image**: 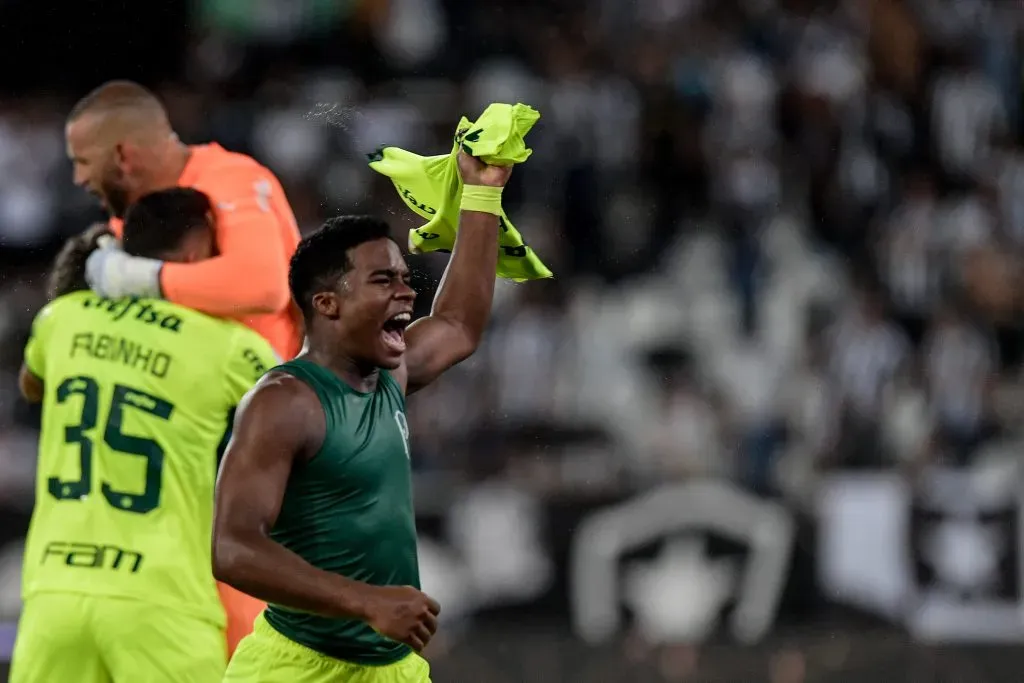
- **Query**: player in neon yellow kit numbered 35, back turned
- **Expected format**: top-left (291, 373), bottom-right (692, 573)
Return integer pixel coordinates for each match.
top-left (11, 188), bottom-right (278, 683)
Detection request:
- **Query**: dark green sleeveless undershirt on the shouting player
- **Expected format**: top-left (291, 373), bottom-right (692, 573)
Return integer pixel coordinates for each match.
top-left (265, 359), bottom-right (420, 665)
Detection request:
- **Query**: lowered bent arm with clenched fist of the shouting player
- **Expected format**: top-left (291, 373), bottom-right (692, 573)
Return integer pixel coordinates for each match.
top-left (213, 374), bottom-right (438, 650)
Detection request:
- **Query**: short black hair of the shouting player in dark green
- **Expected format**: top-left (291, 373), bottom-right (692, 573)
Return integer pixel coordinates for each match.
top-left (288, 216), bottom-right (391, 321)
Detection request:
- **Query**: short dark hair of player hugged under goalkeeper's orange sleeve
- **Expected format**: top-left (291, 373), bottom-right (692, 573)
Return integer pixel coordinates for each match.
top-left (121, 187), bottom-right (213, 260)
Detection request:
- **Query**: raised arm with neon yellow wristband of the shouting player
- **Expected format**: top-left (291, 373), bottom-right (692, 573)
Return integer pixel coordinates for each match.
top-left (398, 152), bottom-right (512, 393)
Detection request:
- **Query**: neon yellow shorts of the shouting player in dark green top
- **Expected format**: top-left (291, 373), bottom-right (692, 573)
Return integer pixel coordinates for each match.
top-left (224, 614), bottom-right (430, 683)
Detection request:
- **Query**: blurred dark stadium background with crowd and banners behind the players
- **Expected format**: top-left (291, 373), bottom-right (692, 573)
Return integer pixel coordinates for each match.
top-left (0, 0), bottom-right (1024, 683)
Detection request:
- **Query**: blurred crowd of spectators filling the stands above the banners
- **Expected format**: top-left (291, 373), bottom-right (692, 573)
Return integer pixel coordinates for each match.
top-left (0, 0), bottom-right (1024, 667)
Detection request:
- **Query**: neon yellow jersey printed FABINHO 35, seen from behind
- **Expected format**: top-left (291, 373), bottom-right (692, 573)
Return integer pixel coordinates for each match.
top-left (23, 292), bottom-right (280, 624)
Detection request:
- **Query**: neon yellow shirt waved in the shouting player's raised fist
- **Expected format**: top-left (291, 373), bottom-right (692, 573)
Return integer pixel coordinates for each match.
top-left (370, 100), bottom-right (552, 282)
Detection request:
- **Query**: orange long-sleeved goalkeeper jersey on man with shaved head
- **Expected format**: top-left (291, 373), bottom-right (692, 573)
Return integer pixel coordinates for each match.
top-left (111, 143), bottom-right (302, 360)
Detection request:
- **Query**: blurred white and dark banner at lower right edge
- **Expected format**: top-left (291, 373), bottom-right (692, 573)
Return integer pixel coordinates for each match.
top-left (818, 468), bottom-right (1024, 643)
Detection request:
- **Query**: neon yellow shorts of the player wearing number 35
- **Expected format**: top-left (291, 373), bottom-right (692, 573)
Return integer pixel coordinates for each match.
top-left (10, 593), bottom-right (227, 683)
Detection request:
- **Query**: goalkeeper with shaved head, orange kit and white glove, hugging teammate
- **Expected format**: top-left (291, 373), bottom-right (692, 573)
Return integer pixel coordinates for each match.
top-left (65, 81), bottom-right (302, 651)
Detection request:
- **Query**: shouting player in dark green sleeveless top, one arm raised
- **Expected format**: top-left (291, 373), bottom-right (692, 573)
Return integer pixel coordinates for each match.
top-left (213, 154), bottom-right (511, 683)
